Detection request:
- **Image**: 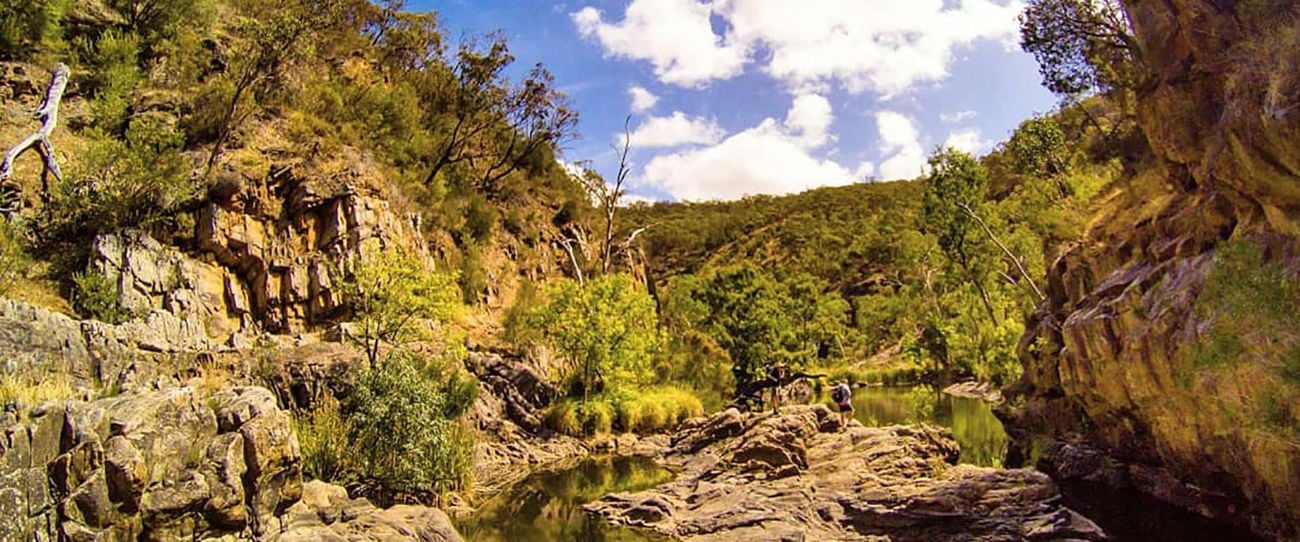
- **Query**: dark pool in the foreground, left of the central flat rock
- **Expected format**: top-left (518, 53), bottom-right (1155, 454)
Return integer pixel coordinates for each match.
top-left (456, 458), bottom-right (672, 542)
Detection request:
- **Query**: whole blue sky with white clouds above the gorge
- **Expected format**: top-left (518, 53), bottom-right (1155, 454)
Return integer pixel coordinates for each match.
top-left (408, 0), bottom-right (1054, 200)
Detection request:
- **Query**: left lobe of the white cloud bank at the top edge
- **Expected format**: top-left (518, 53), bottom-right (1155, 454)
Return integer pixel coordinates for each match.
top-left (572, 0), bottom-right (748, 87)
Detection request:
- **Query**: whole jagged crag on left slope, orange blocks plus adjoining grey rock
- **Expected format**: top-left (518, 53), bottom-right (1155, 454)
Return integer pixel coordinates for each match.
top-left (81, 149), bottom-right (423, 346)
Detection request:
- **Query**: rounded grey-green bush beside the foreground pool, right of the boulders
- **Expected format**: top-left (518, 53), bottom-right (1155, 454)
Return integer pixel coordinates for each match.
top-left (347, 351), bottom-right (473, 494)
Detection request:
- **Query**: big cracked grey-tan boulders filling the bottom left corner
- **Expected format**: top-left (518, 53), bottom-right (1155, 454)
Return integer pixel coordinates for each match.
top-left (0, 387), bottom-right (460, 542)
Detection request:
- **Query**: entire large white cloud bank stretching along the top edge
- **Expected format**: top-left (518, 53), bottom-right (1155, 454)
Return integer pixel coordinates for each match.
top-left (573, 0), bottom-right (1023, 97)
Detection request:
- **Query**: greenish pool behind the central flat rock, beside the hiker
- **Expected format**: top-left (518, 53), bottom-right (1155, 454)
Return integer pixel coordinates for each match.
top-left (837, 386), bottom-right (1006, 467)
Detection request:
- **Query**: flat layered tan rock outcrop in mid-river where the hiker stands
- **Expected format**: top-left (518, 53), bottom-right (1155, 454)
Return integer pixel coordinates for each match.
top-left (588, 406), bottom-right (1105, 541)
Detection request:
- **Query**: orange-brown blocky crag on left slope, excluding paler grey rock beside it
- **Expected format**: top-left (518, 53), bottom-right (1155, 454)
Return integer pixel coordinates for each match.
top-left (196, 155), bottom-right (423, 333)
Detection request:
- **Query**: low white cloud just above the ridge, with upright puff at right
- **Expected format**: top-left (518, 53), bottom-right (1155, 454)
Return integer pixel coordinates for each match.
top-left (637, 96), bottom-right (874, 200)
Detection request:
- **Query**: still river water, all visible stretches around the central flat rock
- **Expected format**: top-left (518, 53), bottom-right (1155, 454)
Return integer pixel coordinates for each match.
top-left (456, 386), bottom-right (1255, 542)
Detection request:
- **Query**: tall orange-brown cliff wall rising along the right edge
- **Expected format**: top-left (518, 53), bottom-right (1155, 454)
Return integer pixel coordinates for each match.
top-left (1005, 0), bottom-right (1300, 538)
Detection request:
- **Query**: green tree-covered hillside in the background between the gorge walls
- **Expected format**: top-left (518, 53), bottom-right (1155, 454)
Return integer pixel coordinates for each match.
top-left (623, 100), bottom-right (1143, 382)
